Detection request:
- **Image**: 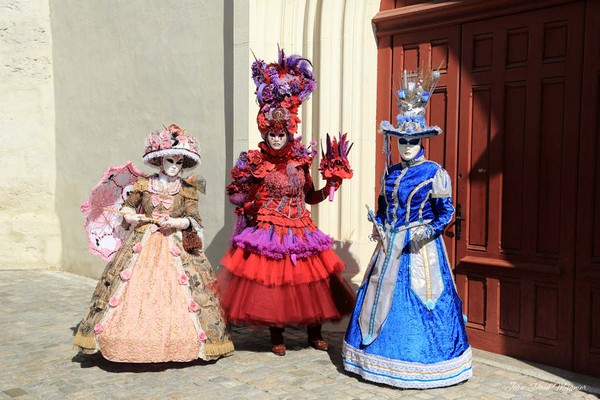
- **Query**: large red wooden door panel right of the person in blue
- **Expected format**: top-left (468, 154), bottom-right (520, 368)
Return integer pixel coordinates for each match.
top-left (456, 3), bottom-right (580, 369)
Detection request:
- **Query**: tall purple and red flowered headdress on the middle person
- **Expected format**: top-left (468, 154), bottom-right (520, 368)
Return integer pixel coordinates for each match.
top-left (252, 49), bottom-right (316, 139)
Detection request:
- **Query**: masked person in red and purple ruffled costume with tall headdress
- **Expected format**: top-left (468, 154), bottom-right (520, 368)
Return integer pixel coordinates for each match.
top-left (218, 50), bottom-right (354, 355)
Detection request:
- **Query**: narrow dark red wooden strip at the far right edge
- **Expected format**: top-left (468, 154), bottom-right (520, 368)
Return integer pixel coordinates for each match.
top-left (573, 1), bottom-right (600, 376)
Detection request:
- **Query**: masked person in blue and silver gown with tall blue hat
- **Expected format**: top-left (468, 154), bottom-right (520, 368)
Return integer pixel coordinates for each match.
top-left (342, 70), bottom-right (472, 389)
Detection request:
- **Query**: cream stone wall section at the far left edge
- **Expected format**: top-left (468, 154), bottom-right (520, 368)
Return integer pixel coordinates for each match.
top-left (0, 0), bottom-right (61, 269)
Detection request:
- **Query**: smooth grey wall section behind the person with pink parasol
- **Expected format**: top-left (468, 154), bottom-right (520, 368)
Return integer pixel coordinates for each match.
top-left (51, 0), bottom-right (233, 277)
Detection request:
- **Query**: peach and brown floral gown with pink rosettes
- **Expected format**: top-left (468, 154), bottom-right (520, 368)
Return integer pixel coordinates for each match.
top-left (74, 178), bottom-right (234, 362)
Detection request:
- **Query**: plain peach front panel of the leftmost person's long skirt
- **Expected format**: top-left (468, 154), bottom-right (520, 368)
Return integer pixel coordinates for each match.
top-left (98, 232), bottom-right (199, 362)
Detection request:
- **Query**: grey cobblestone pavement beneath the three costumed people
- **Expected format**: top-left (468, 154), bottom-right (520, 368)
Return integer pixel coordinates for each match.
top-left (0, 270), bottom-right (600, 400)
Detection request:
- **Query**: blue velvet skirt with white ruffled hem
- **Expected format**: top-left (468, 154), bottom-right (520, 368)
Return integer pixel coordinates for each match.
top-left (342, 237), bottom-right (472, 389)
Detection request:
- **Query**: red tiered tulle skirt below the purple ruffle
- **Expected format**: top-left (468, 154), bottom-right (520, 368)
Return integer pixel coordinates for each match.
top-left (218, 246), bottom-right (346, 327)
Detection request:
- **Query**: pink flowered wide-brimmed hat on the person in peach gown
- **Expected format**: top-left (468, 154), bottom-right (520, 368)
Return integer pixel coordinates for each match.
top-left (143, 124), bottom-right (200, 169)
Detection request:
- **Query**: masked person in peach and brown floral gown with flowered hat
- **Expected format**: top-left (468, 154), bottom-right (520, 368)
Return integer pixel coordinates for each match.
top-left (74, 124), bottom-right (234, 363)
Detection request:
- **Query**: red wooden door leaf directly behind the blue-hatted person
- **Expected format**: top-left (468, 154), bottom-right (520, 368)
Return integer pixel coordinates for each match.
top-left (377, 25), bottom-right (460, 260)
